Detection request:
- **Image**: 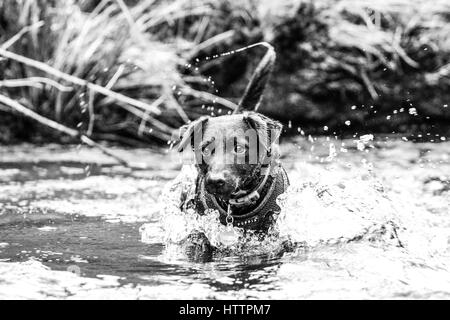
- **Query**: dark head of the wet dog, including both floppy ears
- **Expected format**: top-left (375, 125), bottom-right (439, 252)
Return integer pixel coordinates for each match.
top-left (178, 112), bottom-right (282, 200)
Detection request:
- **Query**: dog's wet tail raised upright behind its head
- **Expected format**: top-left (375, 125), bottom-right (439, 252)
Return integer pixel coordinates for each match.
top-left (234, 43), bottom-right (276, 113)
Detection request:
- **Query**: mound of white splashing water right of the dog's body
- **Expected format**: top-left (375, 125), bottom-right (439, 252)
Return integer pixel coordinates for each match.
top-left (276, 173), bottom-right (398, 247)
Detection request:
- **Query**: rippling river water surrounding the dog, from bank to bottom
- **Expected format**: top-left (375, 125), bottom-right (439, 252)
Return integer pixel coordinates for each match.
top-left (0, 137), bottom-right (450, 299)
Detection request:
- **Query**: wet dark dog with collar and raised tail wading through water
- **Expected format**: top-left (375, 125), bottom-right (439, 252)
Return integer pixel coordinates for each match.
top-left (178, 42), bottom-right (289, 255)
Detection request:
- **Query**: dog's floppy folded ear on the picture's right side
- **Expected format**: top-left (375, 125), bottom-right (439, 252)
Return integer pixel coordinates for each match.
top-left (243, 112), bottom-right (283, 151)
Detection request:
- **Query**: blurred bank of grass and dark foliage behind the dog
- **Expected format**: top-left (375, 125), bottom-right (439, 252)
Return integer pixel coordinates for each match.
top-left (0, 0), bottom-right (450, 146)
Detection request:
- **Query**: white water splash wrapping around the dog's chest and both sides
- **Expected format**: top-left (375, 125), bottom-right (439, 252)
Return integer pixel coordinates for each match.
top-left (141, 160), bottom-right (400, 255)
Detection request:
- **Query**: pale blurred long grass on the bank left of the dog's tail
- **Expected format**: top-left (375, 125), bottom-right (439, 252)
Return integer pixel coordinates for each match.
top-left (1, 0), bottom-right (236, 141)
